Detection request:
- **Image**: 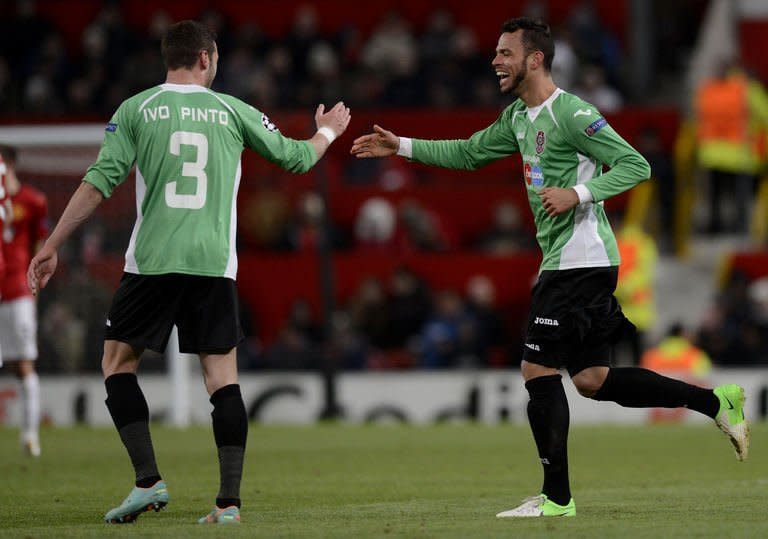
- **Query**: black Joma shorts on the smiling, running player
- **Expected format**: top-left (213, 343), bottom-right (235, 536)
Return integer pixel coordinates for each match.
top-left (523, 267), bottom-right (635, 376)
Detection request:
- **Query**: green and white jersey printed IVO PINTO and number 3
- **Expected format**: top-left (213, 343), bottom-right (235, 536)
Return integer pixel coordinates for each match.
top-left (84, 83), bottom-right (317, 279)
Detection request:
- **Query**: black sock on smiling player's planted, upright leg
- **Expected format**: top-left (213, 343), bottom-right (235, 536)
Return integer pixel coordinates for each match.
top-left (525, 374), bottom-right (571, 505)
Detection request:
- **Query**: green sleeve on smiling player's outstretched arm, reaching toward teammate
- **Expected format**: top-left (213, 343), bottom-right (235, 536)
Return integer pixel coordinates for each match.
top-left (411, 106), bottom-right (518, 170)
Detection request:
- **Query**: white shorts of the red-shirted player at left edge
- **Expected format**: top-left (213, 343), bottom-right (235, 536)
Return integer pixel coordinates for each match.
top-left (0, 296), bottom-right (37, 362)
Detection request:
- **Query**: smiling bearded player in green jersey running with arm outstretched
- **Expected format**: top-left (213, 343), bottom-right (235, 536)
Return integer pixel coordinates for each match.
top-left (351, 17), bottom-right (749, 518)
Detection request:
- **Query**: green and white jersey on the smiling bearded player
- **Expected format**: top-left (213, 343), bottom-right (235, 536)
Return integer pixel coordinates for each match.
top-left (401, 88), bottom-right (650, 270)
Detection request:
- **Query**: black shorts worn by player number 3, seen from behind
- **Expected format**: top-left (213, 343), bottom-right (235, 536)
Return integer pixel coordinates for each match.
top-left (105, 273), bottom-right (243, 354)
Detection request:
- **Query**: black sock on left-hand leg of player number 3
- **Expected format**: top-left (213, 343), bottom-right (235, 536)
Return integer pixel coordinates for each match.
top-left (104, 373), bottom-right (160, 488)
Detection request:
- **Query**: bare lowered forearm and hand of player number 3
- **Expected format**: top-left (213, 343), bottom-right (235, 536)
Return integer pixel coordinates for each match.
top-left (27, 182), bottom-right (104, 295)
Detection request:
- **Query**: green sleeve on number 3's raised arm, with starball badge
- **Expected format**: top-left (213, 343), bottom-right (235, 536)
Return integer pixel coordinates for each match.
top-left (229, 99), bottom-right (317, 173)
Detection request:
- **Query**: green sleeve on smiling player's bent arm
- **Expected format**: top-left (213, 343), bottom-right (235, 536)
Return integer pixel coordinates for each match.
top-left (561, 101), bottom-right (651, 202)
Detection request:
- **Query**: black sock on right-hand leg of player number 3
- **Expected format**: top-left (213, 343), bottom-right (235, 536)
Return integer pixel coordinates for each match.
top-left (211, 384), bottom-right (248, 508)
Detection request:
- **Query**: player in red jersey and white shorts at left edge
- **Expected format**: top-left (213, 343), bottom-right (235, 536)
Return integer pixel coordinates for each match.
top-left (0, 145), bottom-right (48, 457)
